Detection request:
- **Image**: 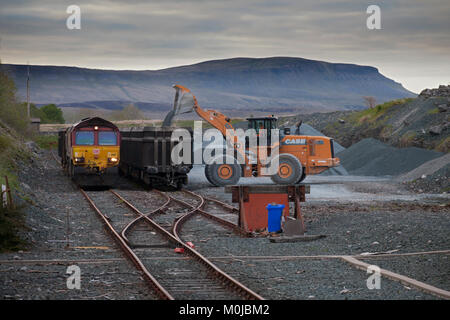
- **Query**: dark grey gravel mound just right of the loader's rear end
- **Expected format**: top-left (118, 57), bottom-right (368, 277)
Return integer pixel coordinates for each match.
top-left (339, 138), bottom-right (443, 176)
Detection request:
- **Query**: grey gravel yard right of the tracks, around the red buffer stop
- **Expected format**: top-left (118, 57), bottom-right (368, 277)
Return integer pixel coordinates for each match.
top-left (183, 165), bottom-right (450, 299)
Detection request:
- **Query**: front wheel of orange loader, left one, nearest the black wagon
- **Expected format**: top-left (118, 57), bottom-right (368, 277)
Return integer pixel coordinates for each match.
top-left (205, 161), bottom-right (241, 187)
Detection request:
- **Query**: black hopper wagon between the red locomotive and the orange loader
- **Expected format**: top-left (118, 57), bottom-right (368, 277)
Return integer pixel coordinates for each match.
top-left (119, 127), bottom-right (193, 189)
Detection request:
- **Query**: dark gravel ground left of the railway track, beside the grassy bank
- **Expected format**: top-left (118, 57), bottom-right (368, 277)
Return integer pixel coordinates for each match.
top-left (0, 152), bottom-right (155, 300)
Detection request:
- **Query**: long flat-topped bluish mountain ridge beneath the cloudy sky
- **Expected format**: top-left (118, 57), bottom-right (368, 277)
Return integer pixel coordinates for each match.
top-left (2, 57), bottom-right (416, 112)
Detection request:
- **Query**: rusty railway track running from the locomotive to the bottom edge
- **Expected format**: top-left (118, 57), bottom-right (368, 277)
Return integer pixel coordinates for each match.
top-left (80, 189), bottom-right (263, 300)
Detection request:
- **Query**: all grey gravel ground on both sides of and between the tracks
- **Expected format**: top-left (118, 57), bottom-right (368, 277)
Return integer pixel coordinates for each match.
top-left (0, 152), bottom-right (450, 299)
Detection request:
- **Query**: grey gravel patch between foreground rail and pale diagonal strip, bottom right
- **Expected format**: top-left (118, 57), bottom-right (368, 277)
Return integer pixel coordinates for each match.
top-left (211, 258), bottom-right (435, 299)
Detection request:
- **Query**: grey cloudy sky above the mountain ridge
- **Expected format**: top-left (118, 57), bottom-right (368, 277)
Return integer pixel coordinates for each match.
top-left (0, 0), bottom-right (450, 92)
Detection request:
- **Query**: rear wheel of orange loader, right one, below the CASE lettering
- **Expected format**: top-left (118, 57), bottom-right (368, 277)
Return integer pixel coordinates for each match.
top-left (270, 153), bottom-right (303, 184)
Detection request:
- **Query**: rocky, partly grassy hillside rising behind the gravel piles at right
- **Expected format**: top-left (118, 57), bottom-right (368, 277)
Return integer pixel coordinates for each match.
top-left (285, 86), bottom-right (450, 152)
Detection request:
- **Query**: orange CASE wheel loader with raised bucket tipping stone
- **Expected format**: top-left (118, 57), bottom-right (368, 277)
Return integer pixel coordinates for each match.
top-left (162, 85), bottom-right (340, 186)
